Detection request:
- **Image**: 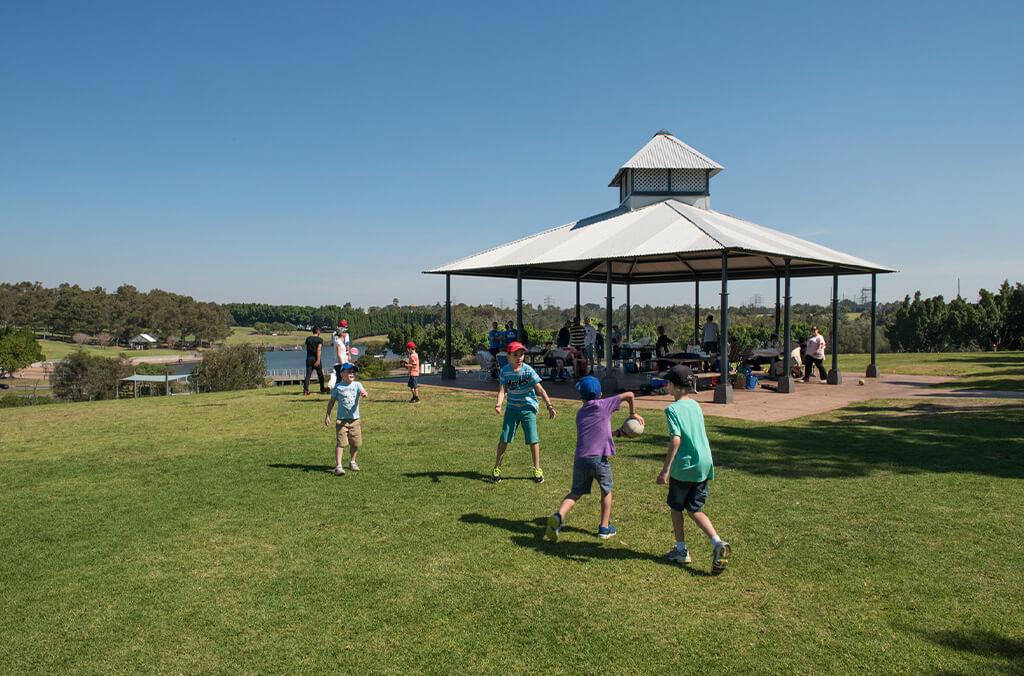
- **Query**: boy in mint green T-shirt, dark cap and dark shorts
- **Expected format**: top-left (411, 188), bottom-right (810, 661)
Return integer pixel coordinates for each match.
top-left (657, 366), bottom-right (731, 575)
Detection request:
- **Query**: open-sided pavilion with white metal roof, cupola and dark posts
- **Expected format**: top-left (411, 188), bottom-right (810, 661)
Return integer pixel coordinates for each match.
top-left (425, 131), bottom-right (895, 404)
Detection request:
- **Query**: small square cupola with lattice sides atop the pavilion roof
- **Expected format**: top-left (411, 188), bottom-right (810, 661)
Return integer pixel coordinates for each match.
top-left (608, 129), bottom-right (723, 211)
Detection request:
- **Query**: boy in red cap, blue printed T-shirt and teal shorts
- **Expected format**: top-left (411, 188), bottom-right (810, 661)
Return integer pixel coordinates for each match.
top-left (490, 340), bottom-right (555, 483)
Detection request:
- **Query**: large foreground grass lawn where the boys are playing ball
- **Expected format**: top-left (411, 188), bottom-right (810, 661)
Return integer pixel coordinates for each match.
top-left (0, 382), bottom-right (1024, 673)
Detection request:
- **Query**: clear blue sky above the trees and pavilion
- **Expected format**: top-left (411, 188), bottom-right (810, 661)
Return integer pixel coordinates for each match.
top-left (0, 1), bottom-right (1024, 305)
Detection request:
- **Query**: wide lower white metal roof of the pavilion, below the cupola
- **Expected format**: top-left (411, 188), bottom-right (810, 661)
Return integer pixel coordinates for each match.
top-left (427, 200), bottom-right (895, 284)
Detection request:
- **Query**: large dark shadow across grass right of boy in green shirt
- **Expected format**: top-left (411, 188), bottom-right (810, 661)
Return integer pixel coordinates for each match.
top-left (623, 402), bottom-right (1024, 478)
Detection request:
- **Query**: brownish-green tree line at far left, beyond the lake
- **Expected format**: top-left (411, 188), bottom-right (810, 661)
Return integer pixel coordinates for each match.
top-left (0, 282), bottom-right (231, 344)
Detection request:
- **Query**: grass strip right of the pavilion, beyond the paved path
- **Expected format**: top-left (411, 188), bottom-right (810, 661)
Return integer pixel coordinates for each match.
top-left (839, 351), bottom-right (1024, 391)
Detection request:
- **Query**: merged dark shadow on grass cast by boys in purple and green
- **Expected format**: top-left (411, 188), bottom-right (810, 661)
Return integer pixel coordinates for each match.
top-left (459, 513), bottom-right (711, 578)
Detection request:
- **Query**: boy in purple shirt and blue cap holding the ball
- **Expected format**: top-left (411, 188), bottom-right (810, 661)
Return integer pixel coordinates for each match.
top-left (544, 376), bottom-right (644, 542)
